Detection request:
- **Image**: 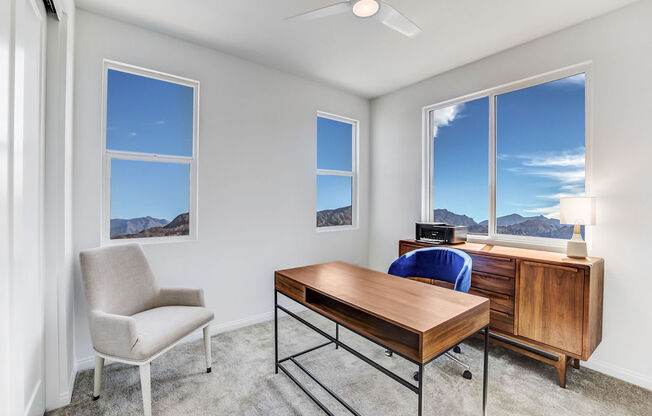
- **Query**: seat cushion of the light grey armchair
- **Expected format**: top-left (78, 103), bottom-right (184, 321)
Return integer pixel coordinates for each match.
top-left (125, 306), bottom-right (213, 361)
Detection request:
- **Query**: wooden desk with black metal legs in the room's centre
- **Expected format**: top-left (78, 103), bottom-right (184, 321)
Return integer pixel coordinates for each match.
top-left (274, 262), bottom-right (489, 415)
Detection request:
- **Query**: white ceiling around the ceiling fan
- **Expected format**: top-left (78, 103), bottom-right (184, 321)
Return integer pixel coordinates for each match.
top-left (77, 0), bottom-right (635, 98)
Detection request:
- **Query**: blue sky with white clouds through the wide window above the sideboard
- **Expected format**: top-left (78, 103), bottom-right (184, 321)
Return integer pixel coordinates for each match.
top-left (433, 74), bottom-right (585, 222)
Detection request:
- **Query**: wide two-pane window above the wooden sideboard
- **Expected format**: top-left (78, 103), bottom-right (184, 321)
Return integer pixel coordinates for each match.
top-left (424, 66), bottom-right (588, 244)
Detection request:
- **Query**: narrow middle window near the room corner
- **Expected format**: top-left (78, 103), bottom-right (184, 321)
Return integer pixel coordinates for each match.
top-left (316, 113), bottom-right (358, 229)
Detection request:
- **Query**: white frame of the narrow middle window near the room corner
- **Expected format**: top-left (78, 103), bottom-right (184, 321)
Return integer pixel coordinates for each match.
top-left (314, 111), bottom-right (360, 232)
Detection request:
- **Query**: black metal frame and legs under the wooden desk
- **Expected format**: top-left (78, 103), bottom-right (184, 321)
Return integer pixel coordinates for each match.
top-left (274, 289), bottom-right (489, 416)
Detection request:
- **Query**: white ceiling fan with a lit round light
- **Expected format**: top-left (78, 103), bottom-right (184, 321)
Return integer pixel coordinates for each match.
top-left (287, 0), bottom-right (421, 38)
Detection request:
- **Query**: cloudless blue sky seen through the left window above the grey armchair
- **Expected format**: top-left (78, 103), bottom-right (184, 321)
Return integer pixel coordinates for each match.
top-left (106, 70), bottom-right (194, 220)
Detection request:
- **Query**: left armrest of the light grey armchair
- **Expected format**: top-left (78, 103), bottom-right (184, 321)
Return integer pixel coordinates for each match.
top-left (90, 310), bottom-right (138, 356)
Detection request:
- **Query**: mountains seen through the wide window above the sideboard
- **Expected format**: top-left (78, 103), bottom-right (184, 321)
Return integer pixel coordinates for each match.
top-left (434, 209), bottom-right (584, 239)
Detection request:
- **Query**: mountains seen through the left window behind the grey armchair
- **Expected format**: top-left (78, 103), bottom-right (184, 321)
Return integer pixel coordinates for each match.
top-left (111, 212), bottom-right (190, 239)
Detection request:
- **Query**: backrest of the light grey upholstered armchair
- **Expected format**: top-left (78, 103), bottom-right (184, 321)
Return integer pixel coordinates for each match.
top-left (79, 244), bottom-right (159, 316)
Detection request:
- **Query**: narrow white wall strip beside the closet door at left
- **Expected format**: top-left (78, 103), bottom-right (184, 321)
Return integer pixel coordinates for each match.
top-left (45, 0), bottom-right (76, 409)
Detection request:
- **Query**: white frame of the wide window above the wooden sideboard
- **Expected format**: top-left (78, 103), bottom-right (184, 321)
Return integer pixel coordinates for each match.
top-left (421, 61), bottom-right (593, 252)
